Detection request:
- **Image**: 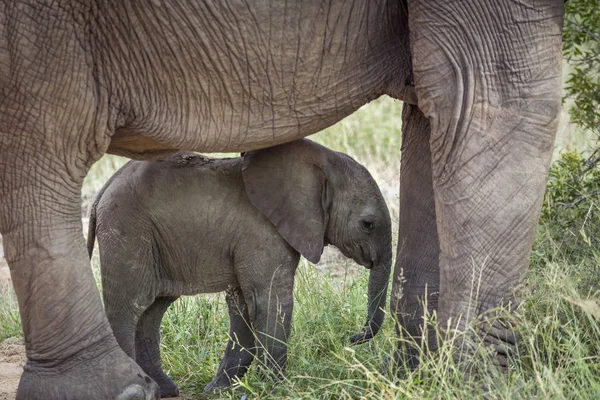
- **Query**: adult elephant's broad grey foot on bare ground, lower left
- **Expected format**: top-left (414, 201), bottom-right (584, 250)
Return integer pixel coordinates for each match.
top-left (17, 347), bottom-right (160, 400)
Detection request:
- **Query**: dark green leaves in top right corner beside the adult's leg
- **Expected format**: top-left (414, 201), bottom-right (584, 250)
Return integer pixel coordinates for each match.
top-left (563, 0), bottom-right (600, 135)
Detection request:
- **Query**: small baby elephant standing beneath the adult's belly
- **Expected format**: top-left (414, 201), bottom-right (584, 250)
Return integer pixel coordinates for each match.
top-left (88, 139), bottom-right (392, 397)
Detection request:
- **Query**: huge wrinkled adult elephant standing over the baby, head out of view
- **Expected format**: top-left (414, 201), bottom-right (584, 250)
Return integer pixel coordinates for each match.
top-left (0, 0), bottom-right (563, 399)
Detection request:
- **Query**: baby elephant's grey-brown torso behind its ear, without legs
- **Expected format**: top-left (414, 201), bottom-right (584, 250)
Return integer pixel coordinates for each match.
top-left (96, 152), bottom-right (268, 278)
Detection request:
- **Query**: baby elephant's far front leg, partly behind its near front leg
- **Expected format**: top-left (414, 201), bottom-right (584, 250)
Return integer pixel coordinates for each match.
top-left (204, 288), bottom-right (254, 392)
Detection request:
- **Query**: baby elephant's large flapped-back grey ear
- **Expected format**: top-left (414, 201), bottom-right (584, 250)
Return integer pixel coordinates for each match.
top-left (242, 140), bottom-right (333, 263)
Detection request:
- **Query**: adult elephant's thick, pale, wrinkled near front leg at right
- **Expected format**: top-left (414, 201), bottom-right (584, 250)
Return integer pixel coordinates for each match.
top-left (408, 0), bottom-right (563, 365)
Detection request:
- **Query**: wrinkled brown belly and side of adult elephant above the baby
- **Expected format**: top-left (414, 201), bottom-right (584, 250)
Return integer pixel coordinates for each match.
top-left (97, 0), bottom-right (412, 159)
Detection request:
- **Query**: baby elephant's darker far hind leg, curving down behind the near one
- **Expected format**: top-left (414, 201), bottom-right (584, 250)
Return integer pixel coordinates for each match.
top-left (135, 297), bottom-right (179, 397)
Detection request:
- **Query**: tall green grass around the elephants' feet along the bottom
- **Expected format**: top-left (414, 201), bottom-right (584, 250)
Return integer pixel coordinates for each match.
top-left (155, 242), bottom-right (600, 399)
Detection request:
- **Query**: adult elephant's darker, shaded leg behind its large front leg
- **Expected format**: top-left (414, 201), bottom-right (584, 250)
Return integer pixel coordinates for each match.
top-left (391, 104), bottom-right (440, 368)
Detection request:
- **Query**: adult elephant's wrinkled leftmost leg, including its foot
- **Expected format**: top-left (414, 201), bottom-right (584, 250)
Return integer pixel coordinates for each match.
top-left (0, 131), bottom-right (158, 399)
